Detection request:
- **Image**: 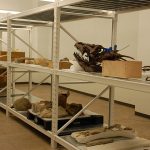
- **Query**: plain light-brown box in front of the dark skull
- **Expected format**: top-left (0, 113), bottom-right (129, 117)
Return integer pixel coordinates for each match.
top-left (102, 60), bottom-right (142, 78)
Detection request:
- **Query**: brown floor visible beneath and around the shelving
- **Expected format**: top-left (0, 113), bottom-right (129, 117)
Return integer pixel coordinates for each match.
top-left (0, 85), bottom-right (150, 150)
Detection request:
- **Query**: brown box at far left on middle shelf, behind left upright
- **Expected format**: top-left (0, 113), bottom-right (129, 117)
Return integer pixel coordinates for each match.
top-left (0, 51), bottom-right (25, 61)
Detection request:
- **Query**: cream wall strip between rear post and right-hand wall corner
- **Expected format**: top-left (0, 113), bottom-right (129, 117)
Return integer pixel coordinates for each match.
top-left (117, 12), bottom-right (139, 59)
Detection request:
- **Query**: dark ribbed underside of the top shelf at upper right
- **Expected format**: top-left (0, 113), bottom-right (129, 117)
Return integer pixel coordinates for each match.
top-left (71, 0), bottom-right (150, 13)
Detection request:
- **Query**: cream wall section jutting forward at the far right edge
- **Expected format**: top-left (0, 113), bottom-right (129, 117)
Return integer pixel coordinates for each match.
top-left (136, 10), bottom-right (150, 115)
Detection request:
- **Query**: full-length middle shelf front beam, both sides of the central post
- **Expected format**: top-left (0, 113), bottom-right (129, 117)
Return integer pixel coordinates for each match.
top-left (0, 61), bottom-right (150, 93)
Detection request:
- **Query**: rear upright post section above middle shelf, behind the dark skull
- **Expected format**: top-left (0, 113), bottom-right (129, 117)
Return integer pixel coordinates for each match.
top-left (111, 13), bottom-right (118, 50)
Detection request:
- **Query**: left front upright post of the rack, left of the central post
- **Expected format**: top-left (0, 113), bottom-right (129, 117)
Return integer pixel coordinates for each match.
top-left (6, 17), bottom-right (11, 117)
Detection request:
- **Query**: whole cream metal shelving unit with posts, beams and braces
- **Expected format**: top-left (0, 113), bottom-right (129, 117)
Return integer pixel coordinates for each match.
top-left (0, 0), bottom-right (150, 150)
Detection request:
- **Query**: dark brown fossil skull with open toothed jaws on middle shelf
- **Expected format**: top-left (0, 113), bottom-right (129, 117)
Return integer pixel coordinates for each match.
top-left (74, 42), bottom-right (133, 72)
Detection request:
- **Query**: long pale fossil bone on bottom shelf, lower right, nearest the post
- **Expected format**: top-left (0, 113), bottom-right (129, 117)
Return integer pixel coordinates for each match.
top-left (71, 124), bottom-right (136, 143)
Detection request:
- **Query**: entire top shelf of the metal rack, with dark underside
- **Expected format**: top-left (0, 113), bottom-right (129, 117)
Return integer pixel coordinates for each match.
top-left (2, 0), bottom-right (150, 25)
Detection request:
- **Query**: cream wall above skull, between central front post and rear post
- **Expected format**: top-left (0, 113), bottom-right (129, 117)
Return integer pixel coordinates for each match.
top-left (60, 18), bottom-right (111, 59)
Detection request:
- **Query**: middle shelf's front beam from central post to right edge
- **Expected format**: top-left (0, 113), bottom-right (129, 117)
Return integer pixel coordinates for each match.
top-left (57, 70), bottom-right (150, 93)
